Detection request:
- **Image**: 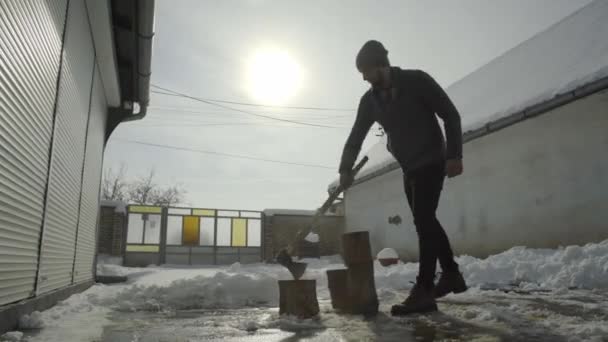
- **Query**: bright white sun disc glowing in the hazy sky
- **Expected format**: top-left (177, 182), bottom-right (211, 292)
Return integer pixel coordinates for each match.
top-left (247, 48), bottom-right (303, 105)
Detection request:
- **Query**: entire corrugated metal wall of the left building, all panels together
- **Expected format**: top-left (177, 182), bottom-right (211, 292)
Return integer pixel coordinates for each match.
top-left (0, 0), bottom-right (107, 309)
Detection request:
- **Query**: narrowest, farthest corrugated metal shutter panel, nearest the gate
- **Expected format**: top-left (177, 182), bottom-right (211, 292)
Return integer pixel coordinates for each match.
top-left (74, 68), bottom-right (107, 283)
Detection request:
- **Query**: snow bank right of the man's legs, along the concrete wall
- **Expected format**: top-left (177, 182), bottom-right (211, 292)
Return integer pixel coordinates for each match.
top-left (458, 240), bottom-right (608, 289)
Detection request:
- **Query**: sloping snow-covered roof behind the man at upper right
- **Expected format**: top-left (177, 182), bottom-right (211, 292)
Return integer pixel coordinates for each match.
top-left (330, 0), bottom-right (608, 188)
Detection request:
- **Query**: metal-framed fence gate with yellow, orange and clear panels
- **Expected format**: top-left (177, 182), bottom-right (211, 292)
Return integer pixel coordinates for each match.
top-left (125, 205), bottom-right (263, 266)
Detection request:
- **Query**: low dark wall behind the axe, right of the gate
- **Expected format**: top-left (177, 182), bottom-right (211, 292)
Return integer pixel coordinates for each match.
top-left (263, 215), bottom-right (344, 262)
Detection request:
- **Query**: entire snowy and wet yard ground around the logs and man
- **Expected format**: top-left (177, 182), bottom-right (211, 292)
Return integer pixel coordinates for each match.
top-left (0, 240), bottom-right (608, 342)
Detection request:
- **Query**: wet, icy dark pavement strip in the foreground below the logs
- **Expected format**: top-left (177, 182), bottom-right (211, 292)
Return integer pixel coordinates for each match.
top-left (101, 293), bottom-right (608, 342)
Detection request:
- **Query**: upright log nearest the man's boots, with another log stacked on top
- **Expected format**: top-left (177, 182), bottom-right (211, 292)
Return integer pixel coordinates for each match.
top-left (347, 261), bottom-right (378, 315)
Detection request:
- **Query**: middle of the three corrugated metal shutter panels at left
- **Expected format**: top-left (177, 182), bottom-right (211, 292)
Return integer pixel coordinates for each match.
top-left (36, 0), bottom-right (94, 293)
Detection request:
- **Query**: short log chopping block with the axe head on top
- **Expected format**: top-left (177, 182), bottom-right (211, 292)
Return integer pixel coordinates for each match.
top-left (279, 279), bottom-right (319, 318)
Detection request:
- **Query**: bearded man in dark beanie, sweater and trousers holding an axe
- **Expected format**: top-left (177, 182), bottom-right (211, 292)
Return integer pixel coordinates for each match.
top-left (339, 40), bottom-right (467, 315)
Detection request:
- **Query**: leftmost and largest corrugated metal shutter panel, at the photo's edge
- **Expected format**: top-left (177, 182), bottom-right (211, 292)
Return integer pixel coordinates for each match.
top-left (0, 0), bottom-right (67, 305)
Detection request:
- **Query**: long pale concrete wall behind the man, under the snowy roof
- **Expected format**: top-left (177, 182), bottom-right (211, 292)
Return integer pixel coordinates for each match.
top-left (346, 92), bottom-right (608, 260)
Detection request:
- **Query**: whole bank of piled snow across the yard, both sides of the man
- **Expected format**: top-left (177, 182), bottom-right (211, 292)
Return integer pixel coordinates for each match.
top-left (90, 240), bottom-right (608, 311)
